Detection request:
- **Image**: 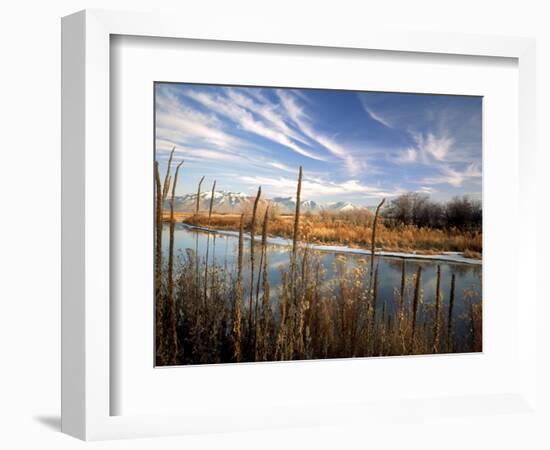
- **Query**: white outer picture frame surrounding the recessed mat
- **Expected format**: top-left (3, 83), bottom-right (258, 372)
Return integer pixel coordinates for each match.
top-left (62, 10), bottom-right (536, 440)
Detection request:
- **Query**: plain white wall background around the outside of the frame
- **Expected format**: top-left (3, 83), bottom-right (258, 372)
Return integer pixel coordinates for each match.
top-left (0, 0), bottom-right (550, 449)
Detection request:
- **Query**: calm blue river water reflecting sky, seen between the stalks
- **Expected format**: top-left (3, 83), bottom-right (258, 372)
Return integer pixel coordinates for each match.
top-left (162, 224), bottom-right (482, 342)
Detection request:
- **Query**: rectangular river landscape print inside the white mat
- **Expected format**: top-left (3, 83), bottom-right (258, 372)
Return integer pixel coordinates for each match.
top-left (152, 82), bottom-right (482, 366)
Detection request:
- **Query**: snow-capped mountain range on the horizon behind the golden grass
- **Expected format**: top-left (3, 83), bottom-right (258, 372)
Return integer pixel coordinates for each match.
top-left (165, 191), bottom-right (369, 214)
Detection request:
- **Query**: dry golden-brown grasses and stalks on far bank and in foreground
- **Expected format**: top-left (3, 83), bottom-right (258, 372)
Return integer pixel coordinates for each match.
top-left (155, 156), bottom-right (482, 365)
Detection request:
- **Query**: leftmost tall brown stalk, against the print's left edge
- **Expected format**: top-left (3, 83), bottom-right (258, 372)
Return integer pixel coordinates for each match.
top-left (155, 161), bottom-right (164, 363)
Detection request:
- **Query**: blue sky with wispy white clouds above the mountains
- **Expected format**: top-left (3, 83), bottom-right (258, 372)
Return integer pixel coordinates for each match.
top-left (155, 83), bottom-right (482, 205)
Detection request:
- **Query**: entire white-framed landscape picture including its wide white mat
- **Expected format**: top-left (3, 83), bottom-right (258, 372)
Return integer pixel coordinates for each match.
top-left (62, 11), bottom-right (536, 440)
